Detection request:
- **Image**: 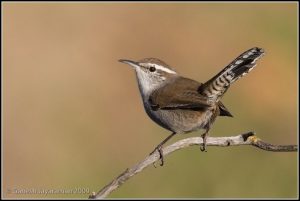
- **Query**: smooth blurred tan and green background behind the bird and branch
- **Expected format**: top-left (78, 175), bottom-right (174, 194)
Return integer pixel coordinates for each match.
top-left (2, 3), bottom-right (298, 198)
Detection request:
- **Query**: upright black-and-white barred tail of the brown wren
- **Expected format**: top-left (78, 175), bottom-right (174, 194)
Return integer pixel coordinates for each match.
top-left (198, 47), bottom-right (264, 101)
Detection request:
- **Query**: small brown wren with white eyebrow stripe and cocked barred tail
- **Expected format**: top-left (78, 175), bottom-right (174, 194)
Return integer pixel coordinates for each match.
top-left (119, 47), bottom-right (264, 165)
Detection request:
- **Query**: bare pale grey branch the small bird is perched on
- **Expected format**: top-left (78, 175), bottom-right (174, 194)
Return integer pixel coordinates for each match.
top-left (89, 132), bottom-right (298, 199)
